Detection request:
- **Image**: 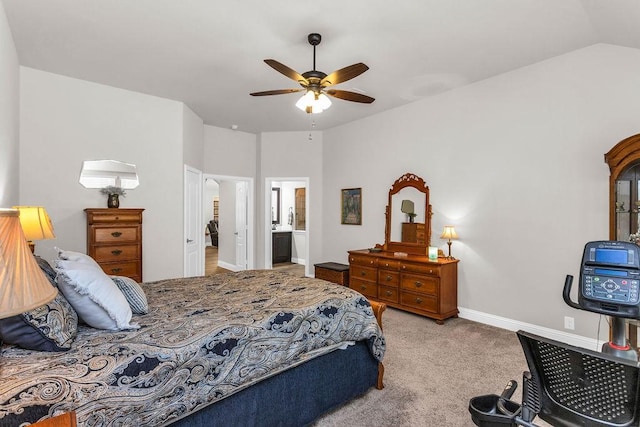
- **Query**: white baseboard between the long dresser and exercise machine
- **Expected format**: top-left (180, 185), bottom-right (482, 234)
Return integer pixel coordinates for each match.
top-left (458, 307), bottom-right (602, 351)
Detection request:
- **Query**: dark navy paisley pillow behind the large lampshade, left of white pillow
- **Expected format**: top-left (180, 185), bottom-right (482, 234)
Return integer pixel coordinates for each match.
top-left (0, 257), bottom-right (78, 351)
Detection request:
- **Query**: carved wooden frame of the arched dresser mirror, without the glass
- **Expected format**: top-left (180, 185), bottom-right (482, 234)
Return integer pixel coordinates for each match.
top-left (384, 173), bottom-right (432, 255)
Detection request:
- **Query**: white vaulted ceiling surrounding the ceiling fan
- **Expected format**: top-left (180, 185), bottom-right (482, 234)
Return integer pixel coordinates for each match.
top-left (2, 0), bottom-right (640, 133)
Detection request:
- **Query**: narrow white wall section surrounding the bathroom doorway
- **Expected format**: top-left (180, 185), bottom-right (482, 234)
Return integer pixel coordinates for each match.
top-left (256, 132), bottom-right (322, 268)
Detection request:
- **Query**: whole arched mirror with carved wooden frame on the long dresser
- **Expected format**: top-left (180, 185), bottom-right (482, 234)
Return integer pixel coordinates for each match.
top-left (384, 173), bottom-right (431, 255)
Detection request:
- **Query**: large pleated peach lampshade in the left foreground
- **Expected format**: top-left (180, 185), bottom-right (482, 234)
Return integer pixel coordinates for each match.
top-left (0, 209), bottom-right (58, 318)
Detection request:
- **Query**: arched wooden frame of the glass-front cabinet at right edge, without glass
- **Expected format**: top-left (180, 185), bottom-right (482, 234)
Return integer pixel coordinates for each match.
top-left (604, 134), bottom-right (640, 240)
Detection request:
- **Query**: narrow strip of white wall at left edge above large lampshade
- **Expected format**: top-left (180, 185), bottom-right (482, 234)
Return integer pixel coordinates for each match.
top-left (0, 2), bottom-right (20, 208)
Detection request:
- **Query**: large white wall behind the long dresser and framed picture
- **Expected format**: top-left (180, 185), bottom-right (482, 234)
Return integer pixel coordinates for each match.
top-left (322, 45), bottom-right (640, 337)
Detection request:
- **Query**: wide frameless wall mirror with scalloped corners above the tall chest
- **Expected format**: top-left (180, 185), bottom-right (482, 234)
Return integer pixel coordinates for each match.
top-left (80, 160), bottom-right (140, 190)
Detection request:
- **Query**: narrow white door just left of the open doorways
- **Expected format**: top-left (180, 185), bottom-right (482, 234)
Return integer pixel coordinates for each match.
top-left (184, 165), bottom-right (204, 277)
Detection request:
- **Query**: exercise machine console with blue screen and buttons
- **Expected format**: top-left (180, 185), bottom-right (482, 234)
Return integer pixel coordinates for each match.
top-left (578, 241), bottom-right (640, 318)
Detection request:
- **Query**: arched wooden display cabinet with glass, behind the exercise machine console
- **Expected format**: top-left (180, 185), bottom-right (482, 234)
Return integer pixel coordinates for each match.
top-left (604, 134), bottom-right (640, 243)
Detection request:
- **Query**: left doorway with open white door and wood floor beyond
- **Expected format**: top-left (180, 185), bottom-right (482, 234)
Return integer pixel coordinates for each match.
top-left (202, 174), bottom-right (254, 274)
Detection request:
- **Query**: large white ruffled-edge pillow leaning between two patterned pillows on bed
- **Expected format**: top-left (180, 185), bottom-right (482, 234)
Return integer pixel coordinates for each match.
top-left (56, 260), bottom-right (140, 330)
